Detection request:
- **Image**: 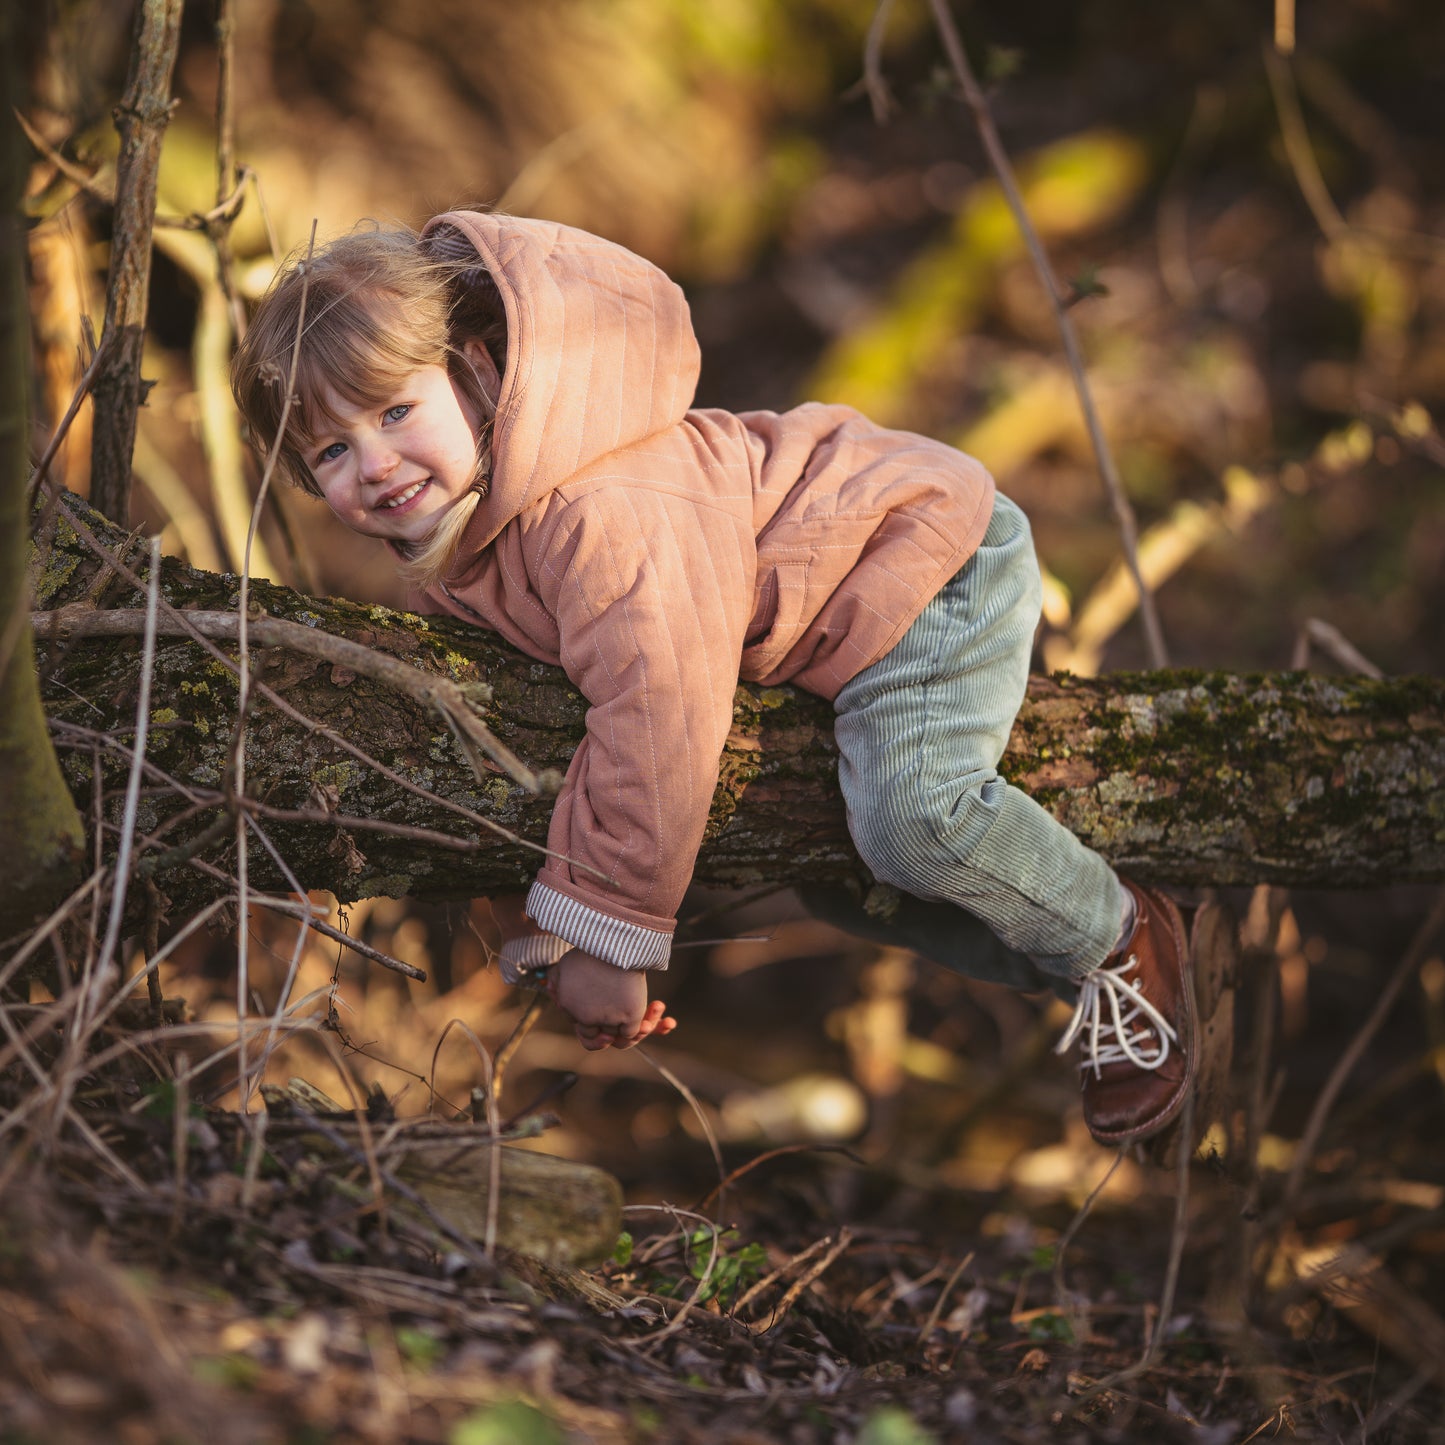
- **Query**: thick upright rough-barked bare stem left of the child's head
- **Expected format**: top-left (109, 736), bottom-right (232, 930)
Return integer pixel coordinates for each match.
top-left (91, 0), bottom-right (182, 526)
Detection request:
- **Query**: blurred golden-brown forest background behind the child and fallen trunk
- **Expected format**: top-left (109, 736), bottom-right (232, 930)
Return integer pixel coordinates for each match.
top-left (11, 0), bottom-right (1445, 1441)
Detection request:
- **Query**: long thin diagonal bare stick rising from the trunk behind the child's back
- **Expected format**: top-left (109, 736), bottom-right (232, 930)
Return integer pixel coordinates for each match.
top-left (929, 0), bottom-right (1169, 668)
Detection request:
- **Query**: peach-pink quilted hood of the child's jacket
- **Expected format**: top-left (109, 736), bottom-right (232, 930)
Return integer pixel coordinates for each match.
top-left (426, 211), bottom-right (699, 555)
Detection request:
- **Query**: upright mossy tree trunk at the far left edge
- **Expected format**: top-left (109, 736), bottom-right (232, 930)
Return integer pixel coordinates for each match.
top-left (0, 28), bottom-right (84, 938)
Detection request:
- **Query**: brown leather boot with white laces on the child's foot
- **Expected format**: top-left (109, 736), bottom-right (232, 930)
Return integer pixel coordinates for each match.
top-left (1058, 879), bottom-right (1195, 1144)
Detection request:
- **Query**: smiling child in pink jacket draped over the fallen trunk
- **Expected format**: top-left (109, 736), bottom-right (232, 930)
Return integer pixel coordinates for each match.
top-left (233, 211), bottom-right (1194, 1143)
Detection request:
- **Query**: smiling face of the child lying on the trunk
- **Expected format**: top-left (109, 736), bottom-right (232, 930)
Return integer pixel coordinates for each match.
top-left (308, 366), bottom-right (477, 542)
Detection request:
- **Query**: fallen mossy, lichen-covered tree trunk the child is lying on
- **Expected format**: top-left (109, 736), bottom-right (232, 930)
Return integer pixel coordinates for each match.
top-left (38, 499), bottom-right (1445, 903)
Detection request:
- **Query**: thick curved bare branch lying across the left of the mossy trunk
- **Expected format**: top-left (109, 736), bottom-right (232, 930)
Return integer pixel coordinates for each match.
top-left (30, 603), bottom-right (548, 796)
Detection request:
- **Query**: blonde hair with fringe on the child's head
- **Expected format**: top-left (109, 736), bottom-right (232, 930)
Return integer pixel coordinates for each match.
top-left (231, 225), bottom-right (506, 587)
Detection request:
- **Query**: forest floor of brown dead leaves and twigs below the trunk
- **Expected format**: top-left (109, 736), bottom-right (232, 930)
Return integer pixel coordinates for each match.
top-left (0, 890), bottom-right (1445, 1445)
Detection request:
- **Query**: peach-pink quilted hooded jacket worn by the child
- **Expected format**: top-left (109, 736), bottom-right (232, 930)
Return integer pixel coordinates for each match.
top-left (429, 211), bottom-right (993, 968)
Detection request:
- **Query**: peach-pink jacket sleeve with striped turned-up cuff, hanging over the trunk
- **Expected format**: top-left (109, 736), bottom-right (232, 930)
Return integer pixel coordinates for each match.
top-left (527, 483), bottom-right (756, 968)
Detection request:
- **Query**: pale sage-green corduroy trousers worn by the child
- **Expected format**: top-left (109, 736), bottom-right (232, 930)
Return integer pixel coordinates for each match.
top-left (835, 496), bottom-right (1123, 978)
